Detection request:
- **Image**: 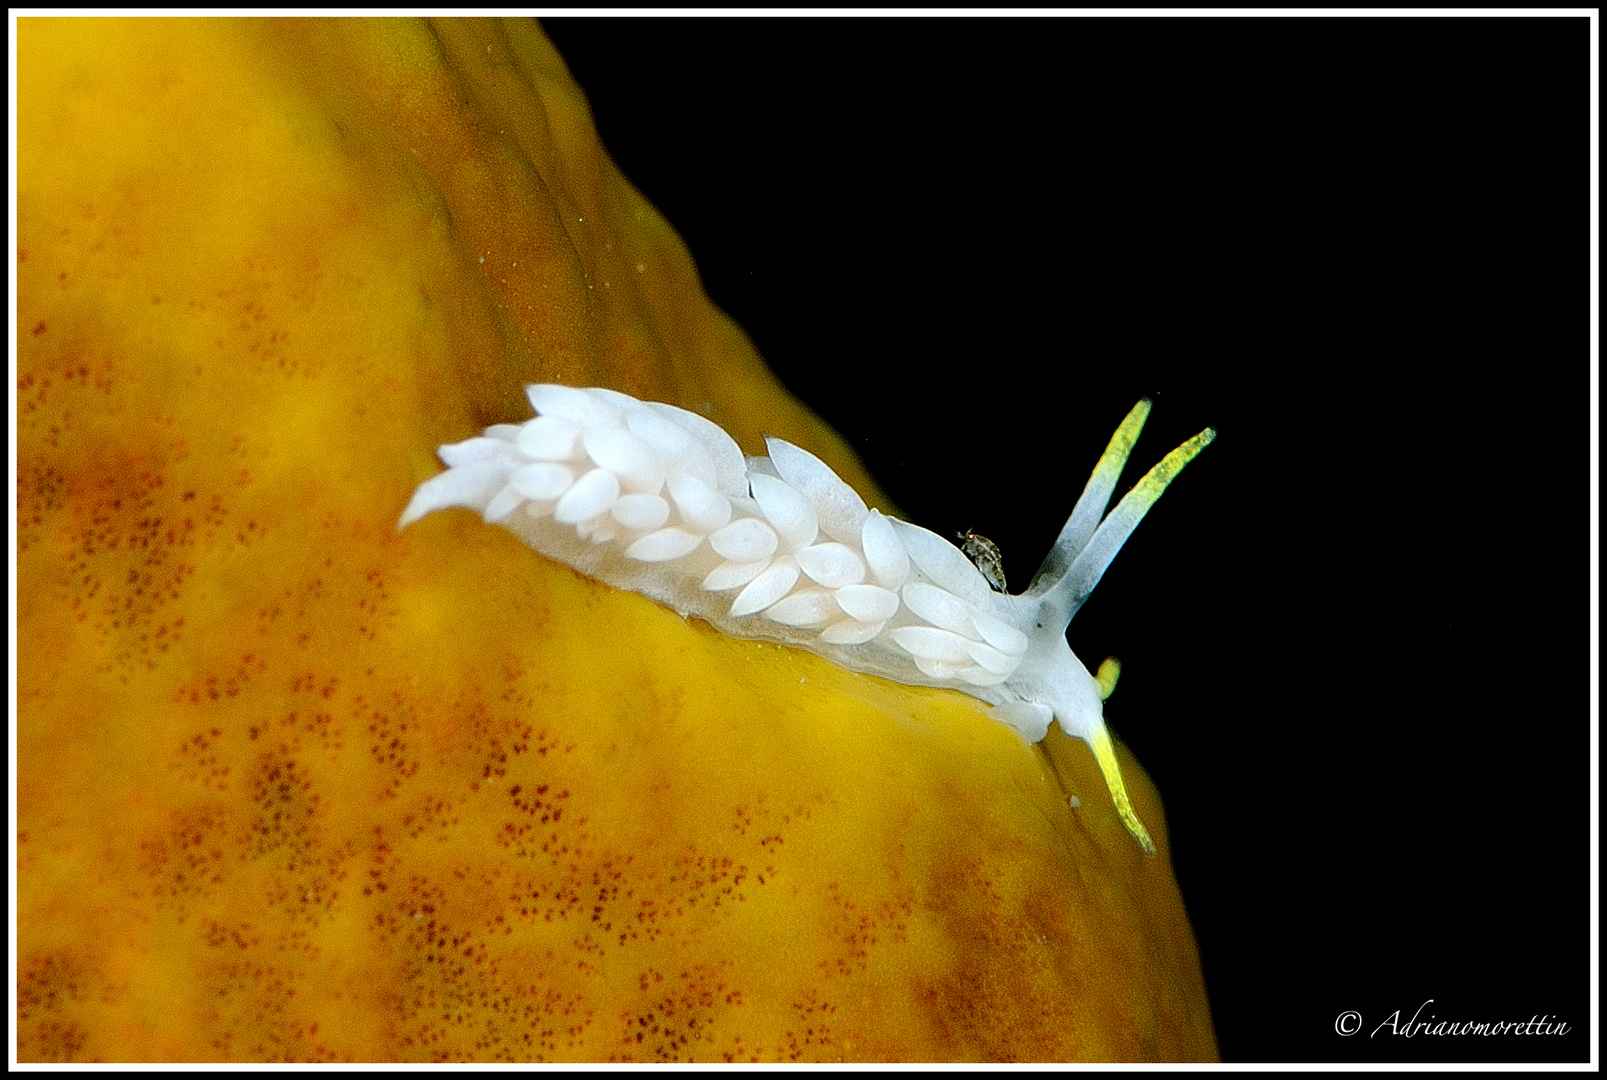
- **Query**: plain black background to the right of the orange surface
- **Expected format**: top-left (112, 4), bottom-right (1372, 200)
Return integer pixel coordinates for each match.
top-left (545, 19), bottom-right (1593, 1062)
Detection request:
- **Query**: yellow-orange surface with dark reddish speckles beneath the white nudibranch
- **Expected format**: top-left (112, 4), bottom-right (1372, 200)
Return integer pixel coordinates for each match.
top-left (16, 19), bottom-right (1215, 1061)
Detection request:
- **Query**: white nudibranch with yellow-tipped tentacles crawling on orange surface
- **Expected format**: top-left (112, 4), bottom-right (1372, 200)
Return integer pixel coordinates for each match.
top-left (397, 384), bottom-right (1216, 853)
